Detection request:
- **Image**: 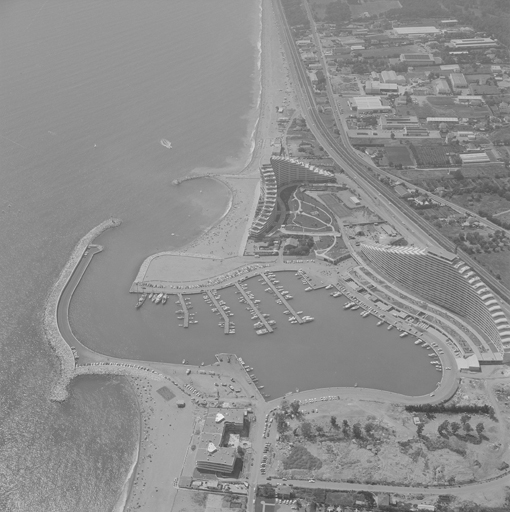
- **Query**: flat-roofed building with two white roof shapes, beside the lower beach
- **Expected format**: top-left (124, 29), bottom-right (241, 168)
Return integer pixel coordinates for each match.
top-left (196, 408), bottom-right (246, 473)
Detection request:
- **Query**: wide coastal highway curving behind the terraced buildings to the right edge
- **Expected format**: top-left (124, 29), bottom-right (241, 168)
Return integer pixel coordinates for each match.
top-left (274, 0), bottom-right (510, 303)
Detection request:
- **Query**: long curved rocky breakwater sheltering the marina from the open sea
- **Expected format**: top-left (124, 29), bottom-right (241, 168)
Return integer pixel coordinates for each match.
top-left (44, 219), bottom-right (122, 402)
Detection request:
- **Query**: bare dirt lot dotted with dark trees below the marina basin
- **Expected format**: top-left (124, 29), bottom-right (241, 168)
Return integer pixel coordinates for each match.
top-left (268, 379), bottom-right (510, 485)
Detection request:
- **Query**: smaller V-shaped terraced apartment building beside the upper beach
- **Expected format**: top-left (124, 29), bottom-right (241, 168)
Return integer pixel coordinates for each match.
top-left (250, 156), bottom-right (335, 236)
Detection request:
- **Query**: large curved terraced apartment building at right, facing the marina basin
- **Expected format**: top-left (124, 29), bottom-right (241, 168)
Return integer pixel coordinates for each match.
top-left (360, 244), bottom-right (510, 352)
